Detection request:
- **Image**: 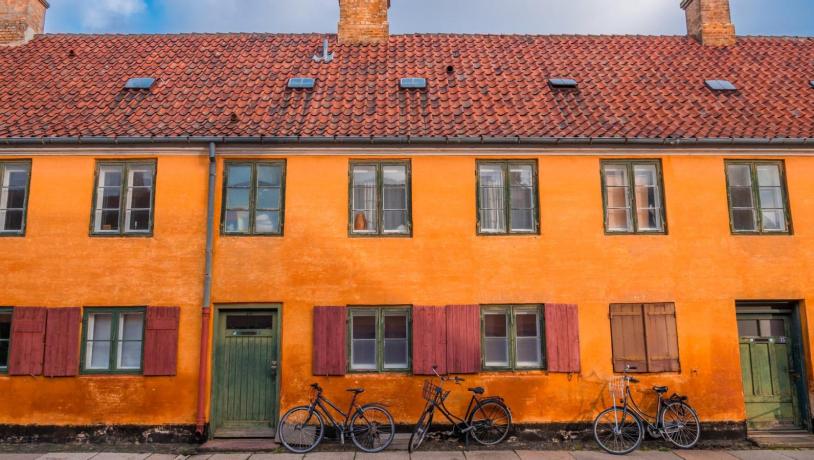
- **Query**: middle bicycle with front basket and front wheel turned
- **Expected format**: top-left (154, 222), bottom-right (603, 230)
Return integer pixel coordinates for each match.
top-left (408, 366), bottom-right (512, 453)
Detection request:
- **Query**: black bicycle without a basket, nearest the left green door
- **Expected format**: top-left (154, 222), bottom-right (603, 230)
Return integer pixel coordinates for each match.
top-left (277, 383), bottom-right (396, 454)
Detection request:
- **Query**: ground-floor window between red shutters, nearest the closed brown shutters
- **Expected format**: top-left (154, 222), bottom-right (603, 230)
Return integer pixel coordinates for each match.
top-left (482, 305), bottom-right (545, 369)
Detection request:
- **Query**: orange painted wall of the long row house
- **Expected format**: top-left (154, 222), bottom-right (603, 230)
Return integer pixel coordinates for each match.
top-left (0, 150), bottom-right (814, 424)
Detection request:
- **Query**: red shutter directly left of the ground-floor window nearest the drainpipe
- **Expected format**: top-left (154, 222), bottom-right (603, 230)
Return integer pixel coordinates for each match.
top-left (43, 308), bottom-right (82, 377)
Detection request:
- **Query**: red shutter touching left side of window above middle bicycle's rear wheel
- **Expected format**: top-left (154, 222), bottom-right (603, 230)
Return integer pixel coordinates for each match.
top-left (447, 305), bottom-right (481, 374)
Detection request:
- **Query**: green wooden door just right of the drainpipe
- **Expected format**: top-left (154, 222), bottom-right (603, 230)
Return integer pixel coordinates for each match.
top-left (213, 311), bottom-right (279, 438)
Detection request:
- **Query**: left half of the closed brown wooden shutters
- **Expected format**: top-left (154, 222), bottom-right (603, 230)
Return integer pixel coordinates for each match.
top-left (610, 304), bottom-right (647, 372)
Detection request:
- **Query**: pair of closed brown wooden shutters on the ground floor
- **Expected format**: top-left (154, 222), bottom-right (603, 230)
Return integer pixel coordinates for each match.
top-left (610, 303), bottom-right (681, 372)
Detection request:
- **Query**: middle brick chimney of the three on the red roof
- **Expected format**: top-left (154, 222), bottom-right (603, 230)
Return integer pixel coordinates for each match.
top-left (338, 0), bottom-right (390, 44)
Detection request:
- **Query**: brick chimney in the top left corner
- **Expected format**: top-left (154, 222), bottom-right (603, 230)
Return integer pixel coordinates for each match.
top-left (0, 0), bottom-right (50, 46)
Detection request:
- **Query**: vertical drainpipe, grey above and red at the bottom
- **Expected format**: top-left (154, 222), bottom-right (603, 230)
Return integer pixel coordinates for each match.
top-left (195, 142), bottom-right (217, 436)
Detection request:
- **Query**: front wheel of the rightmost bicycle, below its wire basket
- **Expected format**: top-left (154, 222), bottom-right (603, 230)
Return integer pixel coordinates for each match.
top-left (594, 407), bottom-right (644, 455)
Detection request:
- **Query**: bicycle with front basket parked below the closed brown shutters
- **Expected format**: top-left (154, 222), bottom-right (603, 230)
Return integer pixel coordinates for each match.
top-left (594, 366), bottom-right (701, 455)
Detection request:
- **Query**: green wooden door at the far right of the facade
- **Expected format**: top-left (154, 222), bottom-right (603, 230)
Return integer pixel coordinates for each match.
top-left (738, 314), bottom-right (801, 430)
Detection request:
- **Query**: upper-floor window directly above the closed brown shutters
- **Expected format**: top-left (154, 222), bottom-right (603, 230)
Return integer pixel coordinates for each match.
top-left (602, 160), bottom-right (666, 233)
